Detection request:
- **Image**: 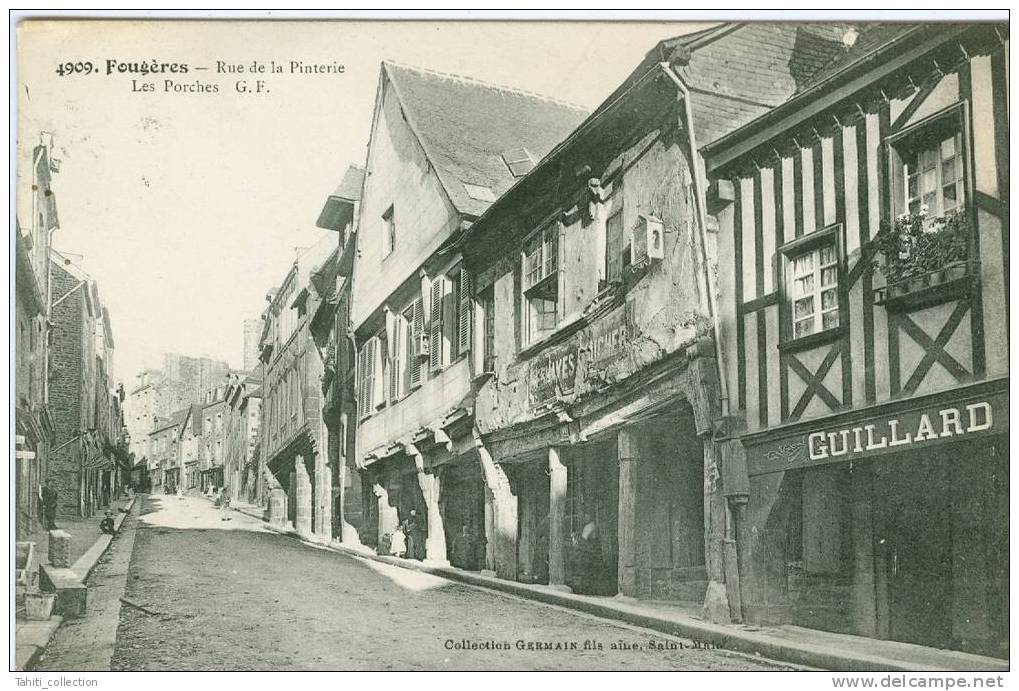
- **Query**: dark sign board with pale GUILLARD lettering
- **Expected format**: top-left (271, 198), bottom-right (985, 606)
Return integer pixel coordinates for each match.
top-left (747, 393), bottom-right (1009, 475)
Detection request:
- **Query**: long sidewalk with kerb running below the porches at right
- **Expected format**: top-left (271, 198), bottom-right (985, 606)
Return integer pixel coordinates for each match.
top-left (233, 504), bottom-right (1009, 672)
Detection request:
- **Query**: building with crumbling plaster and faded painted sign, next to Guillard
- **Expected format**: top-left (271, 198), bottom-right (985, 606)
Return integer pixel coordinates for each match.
top-left (458, 42), bottom-right (736, 607)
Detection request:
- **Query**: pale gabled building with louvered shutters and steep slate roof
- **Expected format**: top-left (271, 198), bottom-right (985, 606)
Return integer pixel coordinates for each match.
top-left (351, 63), bottom-right (584, 569)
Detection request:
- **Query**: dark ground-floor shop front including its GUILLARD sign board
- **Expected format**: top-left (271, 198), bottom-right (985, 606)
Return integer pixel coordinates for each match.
top-left (740, 380), bottom-right (1008, 655)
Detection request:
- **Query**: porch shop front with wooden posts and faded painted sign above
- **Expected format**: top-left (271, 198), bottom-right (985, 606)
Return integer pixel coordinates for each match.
top-left (476, 325), bottom-right (713, 606)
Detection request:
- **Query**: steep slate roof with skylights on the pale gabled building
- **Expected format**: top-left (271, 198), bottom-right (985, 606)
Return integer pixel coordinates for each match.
top-left (382, 62), bottom-right (587, 216)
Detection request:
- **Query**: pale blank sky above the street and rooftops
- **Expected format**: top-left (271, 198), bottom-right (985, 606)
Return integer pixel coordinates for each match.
top-left (17, 20), bottom-right (707, 386)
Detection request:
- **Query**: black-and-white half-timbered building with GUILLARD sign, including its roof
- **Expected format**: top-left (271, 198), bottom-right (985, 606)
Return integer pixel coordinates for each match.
top-left (703, 23), bottom-right (1009, 654)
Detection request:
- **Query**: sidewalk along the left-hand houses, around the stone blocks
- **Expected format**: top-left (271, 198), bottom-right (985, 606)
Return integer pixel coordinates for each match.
top-left (14, 497), bottom-right (137, 671)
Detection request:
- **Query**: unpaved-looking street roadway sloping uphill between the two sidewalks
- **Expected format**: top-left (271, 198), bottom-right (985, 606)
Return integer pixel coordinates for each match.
top-left (39, 495), bottom-right (784, 671)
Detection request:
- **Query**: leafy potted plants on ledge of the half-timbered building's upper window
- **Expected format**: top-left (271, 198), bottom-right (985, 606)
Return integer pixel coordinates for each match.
top-left (875, 207), bottom-right (976, 307)
